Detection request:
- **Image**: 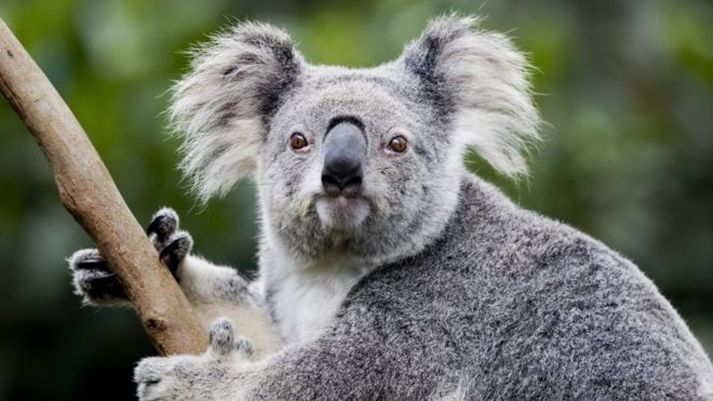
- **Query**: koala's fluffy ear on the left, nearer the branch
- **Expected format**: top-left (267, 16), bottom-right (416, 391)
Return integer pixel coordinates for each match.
top-left (169, 22), bottom-right (304, 201)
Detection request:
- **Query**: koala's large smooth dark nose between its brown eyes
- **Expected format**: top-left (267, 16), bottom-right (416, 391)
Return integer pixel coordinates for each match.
top-left (322, 122), bottom-right (366, 196)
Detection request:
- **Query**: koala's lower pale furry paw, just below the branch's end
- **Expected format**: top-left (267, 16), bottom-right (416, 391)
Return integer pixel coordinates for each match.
top-left (134, 318), bottom-right (252, 401)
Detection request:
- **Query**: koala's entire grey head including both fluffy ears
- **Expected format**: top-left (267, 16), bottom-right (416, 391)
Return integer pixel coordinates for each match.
top-left (171, 16), bottom-right (539, 260)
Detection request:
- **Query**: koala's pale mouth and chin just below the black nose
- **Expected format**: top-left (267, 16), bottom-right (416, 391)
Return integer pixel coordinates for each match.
top-left (315, 195), bottom-right (371, 231)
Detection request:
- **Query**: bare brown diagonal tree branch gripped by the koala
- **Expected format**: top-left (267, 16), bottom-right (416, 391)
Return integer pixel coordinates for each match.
top-left (0, 19), bottom-right (207, 355)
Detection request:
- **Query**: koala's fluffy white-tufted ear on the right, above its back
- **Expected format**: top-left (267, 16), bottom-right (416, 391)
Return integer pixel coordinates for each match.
top-left (401, 16), bottom-right (540, 176)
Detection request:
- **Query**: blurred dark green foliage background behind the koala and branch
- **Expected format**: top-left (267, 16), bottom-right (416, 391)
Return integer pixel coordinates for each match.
top-left (0, 0), bottom-right (713, 400)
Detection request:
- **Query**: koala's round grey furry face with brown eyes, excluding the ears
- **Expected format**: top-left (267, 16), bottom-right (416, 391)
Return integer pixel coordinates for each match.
top-left (258, 66), bottom-right (460, 258)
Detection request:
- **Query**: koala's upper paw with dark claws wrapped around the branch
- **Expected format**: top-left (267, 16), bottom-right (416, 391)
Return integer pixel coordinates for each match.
top-left (67, 208), bottom-right (193, 305)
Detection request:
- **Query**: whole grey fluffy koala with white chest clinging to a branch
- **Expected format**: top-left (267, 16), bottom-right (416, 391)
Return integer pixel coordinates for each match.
top-left (70, 15), bottom-right (713, 401)
